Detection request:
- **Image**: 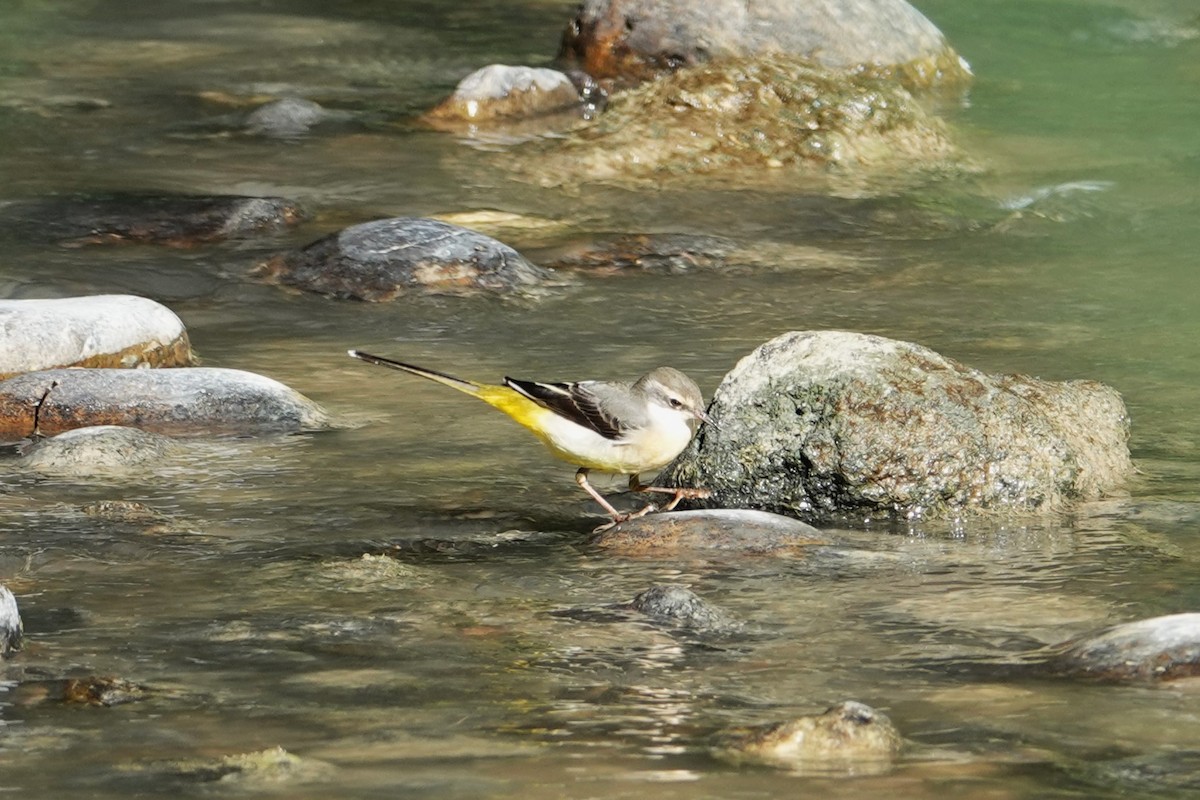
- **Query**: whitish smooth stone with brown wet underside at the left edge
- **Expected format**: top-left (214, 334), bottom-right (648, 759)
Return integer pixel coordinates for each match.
top-left (0, 295), bottom-right (192, 379)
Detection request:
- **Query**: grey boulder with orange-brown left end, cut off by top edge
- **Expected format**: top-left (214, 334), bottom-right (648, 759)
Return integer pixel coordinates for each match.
top-left (559, 0), bottom-right (971, 86)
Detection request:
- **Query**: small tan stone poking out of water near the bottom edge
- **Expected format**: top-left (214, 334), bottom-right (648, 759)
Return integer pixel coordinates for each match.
top-left (713, 700), bottom-right (902, 775)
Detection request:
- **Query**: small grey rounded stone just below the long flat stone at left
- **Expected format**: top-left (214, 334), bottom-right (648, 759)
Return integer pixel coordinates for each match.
top-left (19, 425), bottom-right (179, 475)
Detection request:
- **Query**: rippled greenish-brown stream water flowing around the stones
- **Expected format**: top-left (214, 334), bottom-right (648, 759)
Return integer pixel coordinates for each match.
top-left (0, 0), bottom-right (1200, 798)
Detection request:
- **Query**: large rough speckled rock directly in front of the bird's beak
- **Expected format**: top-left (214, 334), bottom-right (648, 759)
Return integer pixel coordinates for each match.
top-left (661, 331), bottom-right (1132, 519)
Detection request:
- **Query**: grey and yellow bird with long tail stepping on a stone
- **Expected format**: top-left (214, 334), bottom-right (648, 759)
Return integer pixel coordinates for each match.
top-left (347, 350), bottom-right (715, 533)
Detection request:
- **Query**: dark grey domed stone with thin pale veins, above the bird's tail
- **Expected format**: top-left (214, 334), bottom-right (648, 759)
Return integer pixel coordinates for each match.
top-left (258, 217), bottom-right (553, 301)
